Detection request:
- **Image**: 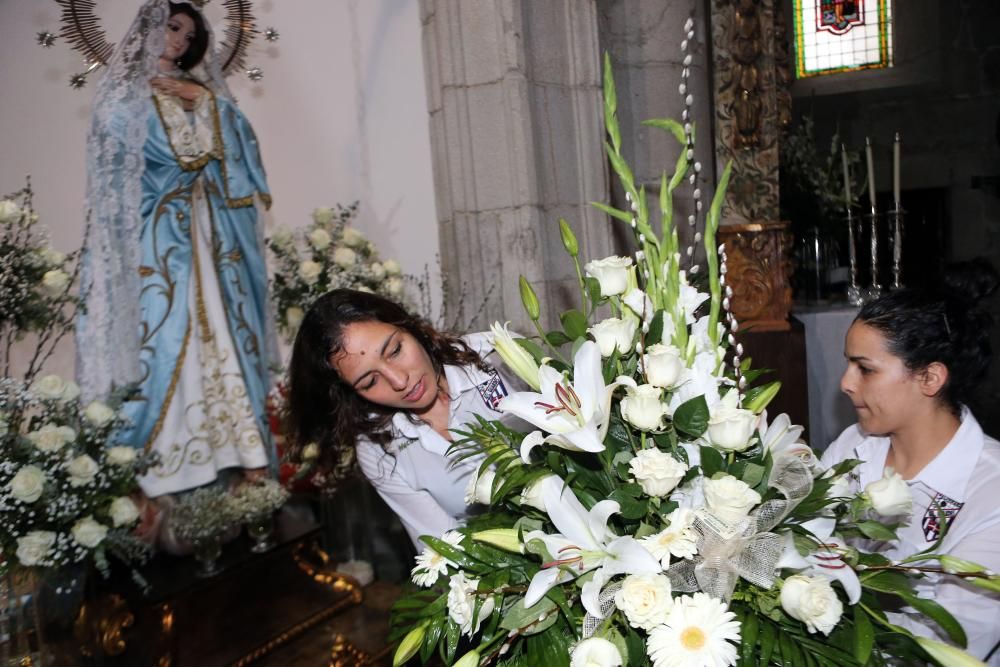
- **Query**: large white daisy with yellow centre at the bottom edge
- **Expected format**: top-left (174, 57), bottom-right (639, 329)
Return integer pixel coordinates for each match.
top-left (646, 593), bottom-right (740, 667)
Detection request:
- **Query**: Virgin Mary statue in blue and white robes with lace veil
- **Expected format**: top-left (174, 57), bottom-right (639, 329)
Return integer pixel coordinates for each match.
top-left (76, 0), bottom-right (273, 498)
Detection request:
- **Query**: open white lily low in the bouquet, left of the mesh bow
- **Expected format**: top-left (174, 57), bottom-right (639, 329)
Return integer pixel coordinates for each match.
top-left (524, 475), bottom-right (660, 618)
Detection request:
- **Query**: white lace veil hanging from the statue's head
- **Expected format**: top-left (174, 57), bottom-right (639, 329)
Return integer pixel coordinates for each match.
top-left (76, 0), bottom-right (232, 400)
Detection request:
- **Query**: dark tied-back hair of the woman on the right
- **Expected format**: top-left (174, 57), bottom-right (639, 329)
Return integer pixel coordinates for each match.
top-left (855, 258), bottom-right (1000, 415)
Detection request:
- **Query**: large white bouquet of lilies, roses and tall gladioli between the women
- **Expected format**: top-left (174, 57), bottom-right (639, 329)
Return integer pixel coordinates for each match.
top-left (392, 56), bottom-right (1000, 667)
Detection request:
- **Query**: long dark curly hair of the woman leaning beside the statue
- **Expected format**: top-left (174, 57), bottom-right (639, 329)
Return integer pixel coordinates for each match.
top-left (285, 289), bottom-right (486, 481)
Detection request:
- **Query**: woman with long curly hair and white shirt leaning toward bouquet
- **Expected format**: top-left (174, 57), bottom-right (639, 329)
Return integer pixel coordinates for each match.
top-left (287, 289), bottom-right (521, 549)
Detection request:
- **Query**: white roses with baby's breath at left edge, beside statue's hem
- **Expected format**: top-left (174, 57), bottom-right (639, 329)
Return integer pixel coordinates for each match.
top-left (0, 375), bottom-right (149, 575)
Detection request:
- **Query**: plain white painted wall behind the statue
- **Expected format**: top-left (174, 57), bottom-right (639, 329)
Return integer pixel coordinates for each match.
top-left (0, 0), bottom-right (438, 373)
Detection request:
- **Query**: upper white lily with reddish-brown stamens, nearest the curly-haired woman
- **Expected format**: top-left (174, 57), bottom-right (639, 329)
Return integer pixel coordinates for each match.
top-left (500, 341), bottom-right (618, 457)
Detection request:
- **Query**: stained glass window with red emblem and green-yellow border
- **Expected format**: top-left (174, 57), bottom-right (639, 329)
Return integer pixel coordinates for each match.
top-left (794, 0), bottom-right (892, 79)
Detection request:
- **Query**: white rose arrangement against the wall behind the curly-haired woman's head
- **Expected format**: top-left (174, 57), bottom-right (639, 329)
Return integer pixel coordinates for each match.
top-left (267, 202), bottom-right (406, 340)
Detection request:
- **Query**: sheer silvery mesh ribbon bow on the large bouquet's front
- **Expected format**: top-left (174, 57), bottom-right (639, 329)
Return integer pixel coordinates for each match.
top-left (667, 456), bottom-right (813, 602)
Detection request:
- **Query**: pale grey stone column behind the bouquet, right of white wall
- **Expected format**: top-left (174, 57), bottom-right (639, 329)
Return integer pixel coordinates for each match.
top-left (420, 0), bottom-right (611, 333)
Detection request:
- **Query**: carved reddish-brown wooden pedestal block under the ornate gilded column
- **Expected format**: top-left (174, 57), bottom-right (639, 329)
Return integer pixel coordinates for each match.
top-left (718, 222), bottom-right (792, 331)
